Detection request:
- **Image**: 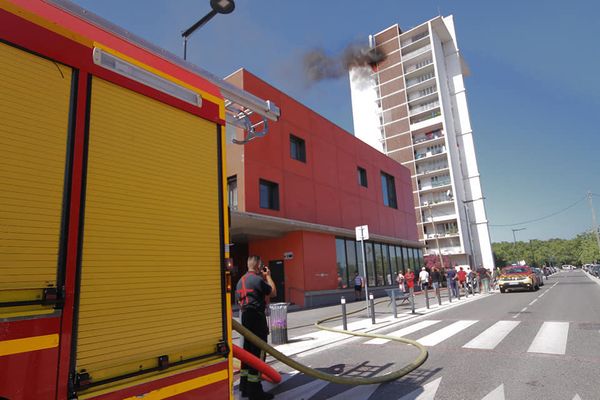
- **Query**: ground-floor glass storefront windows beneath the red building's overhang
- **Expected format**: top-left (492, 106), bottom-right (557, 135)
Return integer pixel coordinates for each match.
top-left (335, 238), bottom-right (423, 288)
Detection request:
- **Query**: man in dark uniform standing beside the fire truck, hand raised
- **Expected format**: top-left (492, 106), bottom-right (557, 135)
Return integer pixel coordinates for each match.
top-left (235, 256), bottom-right (277, 400)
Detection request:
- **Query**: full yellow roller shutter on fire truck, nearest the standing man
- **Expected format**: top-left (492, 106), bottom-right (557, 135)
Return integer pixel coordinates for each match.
top-left (77, 78), bottom-right (223, 382)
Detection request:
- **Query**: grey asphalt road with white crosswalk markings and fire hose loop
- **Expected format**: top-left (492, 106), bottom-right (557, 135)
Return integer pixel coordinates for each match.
top-left (252, 270), bottom-right (600, 400)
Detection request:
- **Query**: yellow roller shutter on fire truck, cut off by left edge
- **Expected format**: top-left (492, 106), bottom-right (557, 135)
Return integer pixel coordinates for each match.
top-left (0, 43), bottom-right (71, 310)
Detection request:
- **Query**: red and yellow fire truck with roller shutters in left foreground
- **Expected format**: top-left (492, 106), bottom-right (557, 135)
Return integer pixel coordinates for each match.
top-left (0, 0), bottom-right (279, 400)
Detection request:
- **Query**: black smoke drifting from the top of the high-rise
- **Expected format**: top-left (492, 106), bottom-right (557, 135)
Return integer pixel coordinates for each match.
top-left (302, 44), bottom-right (386, 83)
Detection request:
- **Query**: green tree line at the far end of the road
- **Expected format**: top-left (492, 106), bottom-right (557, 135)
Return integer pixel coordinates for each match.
top-left (492, 232), bottom-right (600, 267)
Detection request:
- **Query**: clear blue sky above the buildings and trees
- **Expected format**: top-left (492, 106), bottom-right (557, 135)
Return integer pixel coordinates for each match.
top-left (76, 0), bottom-right (600, 241)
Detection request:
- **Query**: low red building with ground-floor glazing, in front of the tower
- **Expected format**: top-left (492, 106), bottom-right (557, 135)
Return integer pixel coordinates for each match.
top-left (226, 69), bottom-right (421, 306)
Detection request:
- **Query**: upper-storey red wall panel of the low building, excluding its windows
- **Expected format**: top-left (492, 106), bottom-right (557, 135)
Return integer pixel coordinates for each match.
top-left (229, 70), bottom-right (418, 241)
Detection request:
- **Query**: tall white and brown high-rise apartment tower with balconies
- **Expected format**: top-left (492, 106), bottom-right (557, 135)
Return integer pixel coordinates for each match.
top-left (350, 16), bottom-right (494, 269)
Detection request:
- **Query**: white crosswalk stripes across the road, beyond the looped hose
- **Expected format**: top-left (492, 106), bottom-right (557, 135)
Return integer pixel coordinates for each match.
top-left (364, 320), bottom-right (570, 355)
